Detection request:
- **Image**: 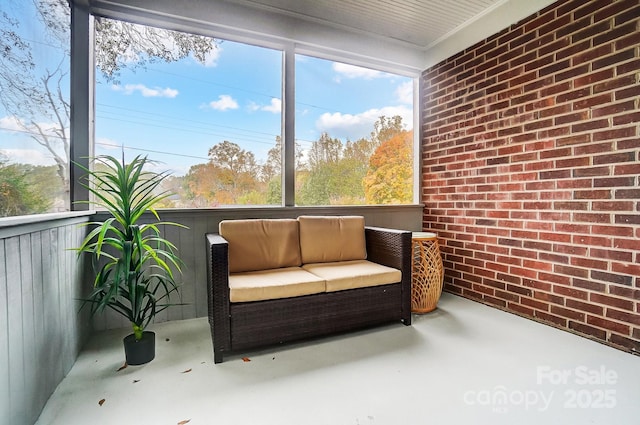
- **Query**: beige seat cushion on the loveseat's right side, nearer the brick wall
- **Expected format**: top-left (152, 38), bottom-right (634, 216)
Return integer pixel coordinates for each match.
top-left (302, 260), bottom-right (402, 292)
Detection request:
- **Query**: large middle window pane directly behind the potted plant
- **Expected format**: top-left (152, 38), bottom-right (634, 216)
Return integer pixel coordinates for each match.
top-left (95, 18), bottom-right (282, 208)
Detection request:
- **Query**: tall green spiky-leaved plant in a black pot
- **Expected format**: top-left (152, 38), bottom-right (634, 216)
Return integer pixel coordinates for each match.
top-left (76, 155), bottom-right (186, 365)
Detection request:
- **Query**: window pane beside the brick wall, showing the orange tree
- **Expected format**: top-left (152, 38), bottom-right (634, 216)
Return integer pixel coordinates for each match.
top-left (295, 55), bottom-right (414, 205)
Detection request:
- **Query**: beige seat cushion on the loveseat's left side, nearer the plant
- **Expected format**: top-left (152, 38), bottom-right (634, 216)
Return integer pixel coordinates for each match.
top-left (229, 267), bottom-right (326, 302)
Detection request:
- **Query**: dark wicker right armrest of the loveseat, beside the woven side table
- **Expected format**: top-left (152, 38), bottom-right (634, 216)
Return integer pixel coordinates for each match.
top-left (365, 226), bottom-right (412, 325)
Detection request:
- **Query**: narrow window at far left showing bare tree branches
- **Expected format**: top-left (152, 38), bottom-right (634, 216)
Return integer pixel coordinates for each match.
top-left (0, 0), bottom-right (70, 217)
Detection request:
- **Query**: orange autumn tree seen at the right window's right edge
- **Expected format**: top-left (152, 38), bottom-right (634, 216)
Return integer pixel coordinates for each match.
top-left (364, 131), bottom-right (413, 204)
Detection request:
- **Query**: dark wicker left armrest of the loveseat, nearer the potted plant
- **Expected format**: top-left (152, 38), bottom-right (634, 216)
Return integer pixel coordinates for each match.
top-left (205, 233), bottom-right (231, 363)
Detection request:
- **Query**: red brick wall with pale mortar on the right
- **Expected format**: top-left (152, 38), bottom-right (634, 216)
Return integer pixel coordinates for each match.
top-left (421, 0), bottom-right (640, 353)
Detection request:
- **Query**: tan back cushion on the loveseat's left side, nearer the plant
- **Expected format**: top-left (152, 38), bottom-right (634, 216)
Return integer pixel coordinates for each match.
top-left (218, 219), bottom-right (301, 273)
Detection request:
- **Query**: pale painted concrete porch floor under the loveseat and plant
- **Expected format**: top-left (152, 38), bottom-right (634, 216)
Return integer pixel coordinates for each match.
top-left (37, 294), bottom-right (640, 425)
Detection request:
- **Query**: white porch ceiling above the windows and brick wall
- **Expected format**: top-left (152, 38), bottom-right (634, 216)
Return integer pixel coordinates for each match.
top-left (87, 0), bottom-right (555, 71)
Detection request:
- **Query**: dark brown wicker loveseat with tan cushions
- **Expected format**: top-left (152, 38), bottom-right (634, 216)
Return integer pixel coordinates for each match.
top-left (206, 216), bottom-right (411, 363)
